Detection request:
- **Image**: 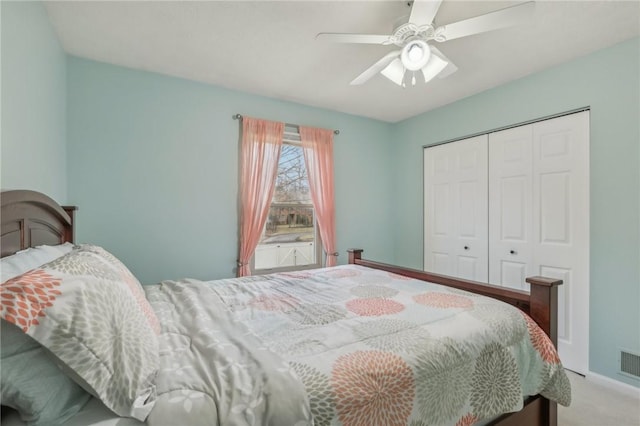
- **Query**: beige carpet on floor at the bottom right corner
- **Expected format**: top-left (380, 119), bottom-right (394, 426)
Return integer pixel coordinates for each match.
top-left (558, 371), bottom-right (640, 426)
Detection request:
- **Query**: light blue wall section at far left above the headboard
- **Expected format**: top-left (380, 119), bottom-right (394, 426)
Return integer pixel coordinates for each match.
top-left (0, 1), bottom-right (67, 203)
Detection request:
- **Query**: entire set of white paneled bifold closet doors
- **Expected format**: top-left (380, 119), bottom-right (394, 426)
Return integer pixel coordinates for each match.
top-left (424, 111), bottom-right (589, 374)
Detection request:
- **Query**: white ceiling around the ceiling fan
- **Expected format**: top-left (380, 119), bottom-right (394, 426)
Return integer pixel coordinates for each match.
top-left (45, 0), bottom-right (640, 122)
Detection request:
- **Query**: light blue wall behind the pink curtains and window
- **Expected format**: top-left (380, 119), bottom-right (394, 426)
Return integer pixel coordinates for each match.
top-left (67, 57), bottom-right (393, 283)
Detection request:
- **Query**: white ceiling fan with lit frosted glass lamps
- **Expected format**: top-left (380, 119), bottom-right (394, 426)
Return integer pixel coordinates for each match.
top-left (316, 0), bottom-right (535, 87)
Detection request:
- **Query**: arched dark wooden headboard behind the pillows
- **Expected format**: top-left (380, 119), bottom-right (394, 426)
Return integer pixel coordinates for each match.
top-left (0, 190), bottom-right (76, 257)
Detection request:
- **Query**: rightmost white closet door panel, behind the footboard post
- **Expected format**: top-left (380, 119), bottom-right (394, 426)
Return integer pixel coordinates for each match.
top-left (532, 111), bottom-right (589, 374)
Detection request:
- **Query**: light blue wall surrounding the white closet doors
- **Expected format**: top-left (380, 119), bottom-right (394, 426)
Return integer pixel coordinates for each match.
top-left (391, 38), bottom-right (640, 386)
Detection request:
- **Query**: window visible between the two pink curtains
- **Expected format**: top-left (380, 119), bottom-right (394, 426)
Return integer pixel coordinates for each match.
top-left (252, 127), bottom-right (322, 273)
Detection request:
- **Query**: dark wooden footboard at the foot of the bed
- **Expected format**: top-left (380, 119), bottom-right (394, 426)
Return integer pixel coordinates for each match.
top-left (347, 249), bottom-right (562, 426)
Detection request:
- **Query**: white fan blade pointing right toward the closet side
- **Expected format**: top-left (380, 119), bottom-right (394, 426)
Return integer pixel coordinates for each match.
top-left (436, 1), bottom-right (535, 41)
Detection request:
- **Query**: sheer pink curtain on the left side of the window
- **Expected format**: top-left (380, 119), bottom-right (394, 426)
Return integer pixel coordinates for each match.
top-left (238, 117), bottom-right (284, 277)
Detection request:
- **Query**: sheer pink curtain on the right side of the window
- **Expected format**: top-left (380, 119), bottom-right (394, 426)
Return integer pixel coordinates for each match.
top-left (300, 126), bottom-right (338, 266)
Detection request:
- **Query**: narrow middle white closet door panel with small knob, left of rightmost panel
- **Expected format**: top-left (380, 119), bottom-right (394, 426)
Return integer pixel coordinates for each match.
top-left (489, 125), bottom-right (533, 290)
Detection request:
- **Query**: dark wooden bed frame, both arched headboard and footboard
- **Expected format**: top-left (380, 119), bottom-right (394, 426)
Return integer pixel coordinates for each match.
top-left (0, 190), bottom-right (562, 426)
